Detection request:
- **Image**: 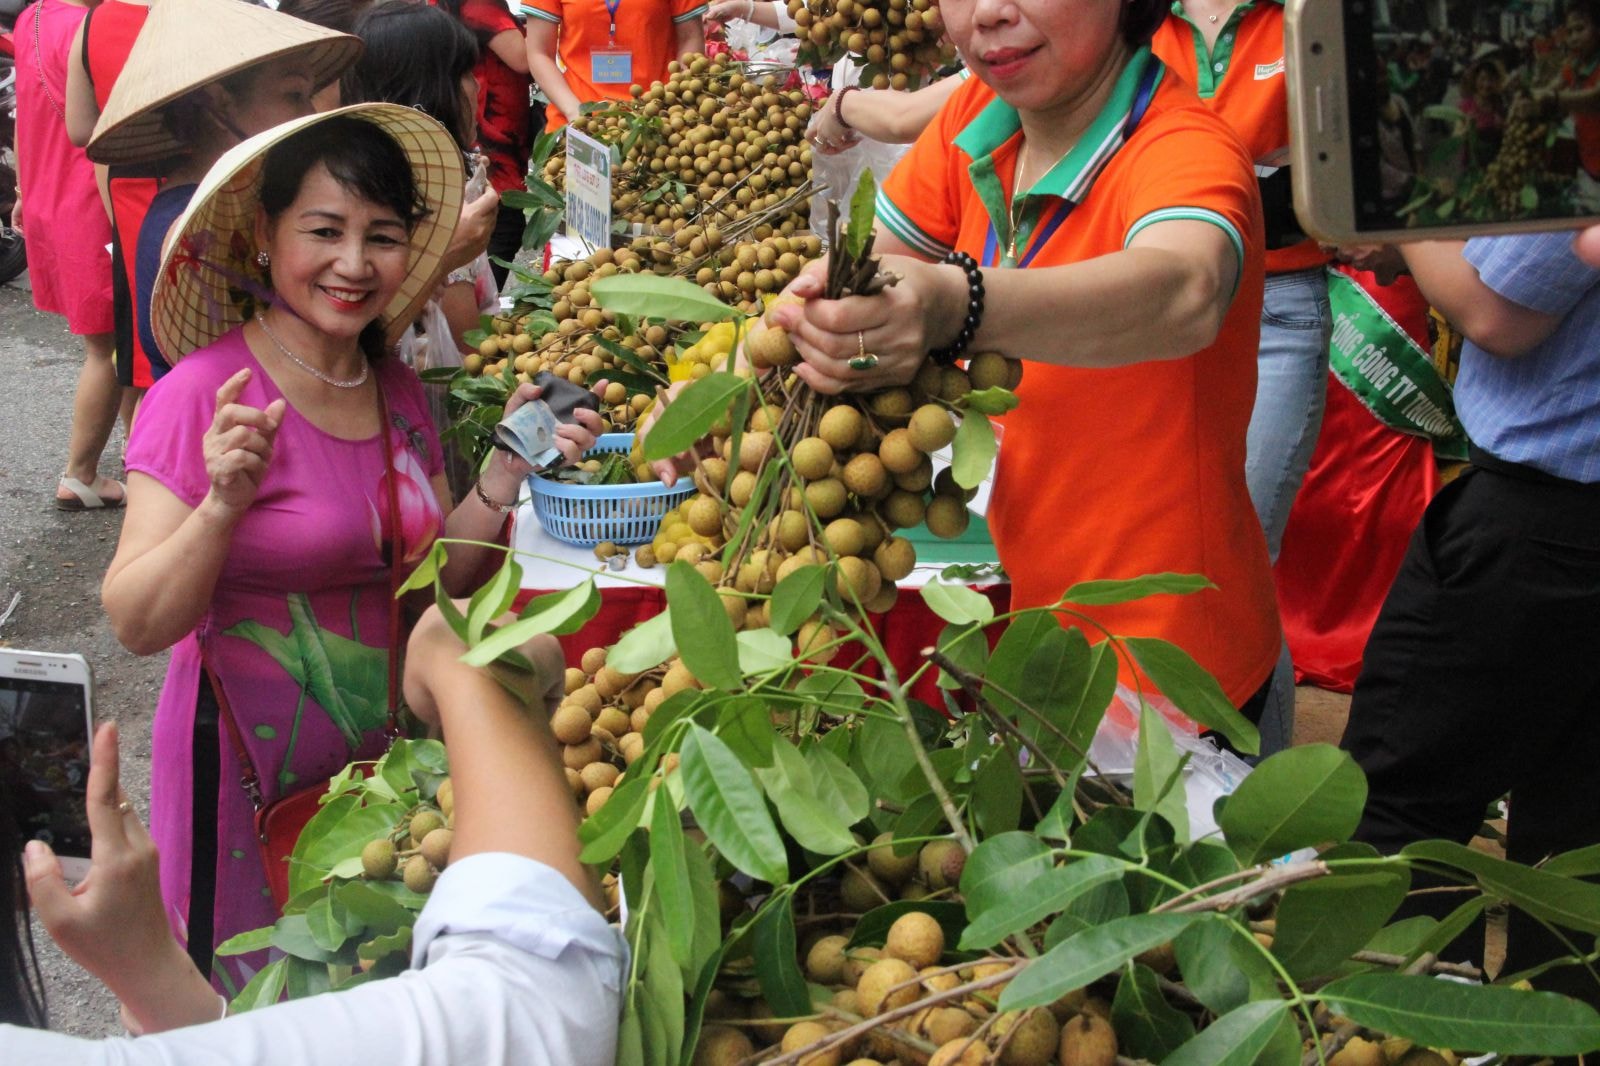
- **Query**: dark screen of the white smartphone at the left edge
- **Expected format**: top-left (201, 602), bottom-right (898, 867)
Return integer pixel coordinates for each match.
top-left (0, 677), bottom-right (90, 856)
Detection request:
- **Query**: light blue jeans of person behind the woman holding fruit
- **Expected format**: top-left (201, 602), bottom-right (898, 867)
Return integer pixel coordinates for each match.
top-left (1245, 267), bottom-right (1333, 755)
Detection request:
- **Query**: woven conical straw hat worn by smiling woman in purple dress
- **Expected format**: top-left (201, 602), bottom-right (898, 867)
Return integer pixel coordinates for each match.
top-left (150, 104), bottom-right (466, 363)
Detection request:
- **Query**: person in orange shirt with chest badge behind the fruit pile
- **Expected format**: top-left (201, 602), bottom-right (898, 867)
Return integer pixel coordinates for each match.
top-left (522, 0), bottom-right (706, 130)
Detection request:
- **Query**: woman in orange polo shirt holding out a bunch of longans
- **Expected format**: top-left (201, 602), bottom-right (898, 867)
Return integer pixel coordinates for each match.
top-left (771, 0), bottom-right (1280, 739)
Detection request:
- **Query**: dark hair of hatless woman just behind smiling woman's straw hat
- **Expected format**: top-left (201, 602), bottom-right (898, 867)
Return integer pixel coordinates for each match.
top-left (339, 3), bottom-right (478, 152)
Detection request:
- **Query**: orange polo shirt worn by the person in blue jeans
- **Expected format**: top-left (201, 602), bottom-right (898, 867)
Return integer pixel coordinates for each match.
top-left (1150, 0), bottom-right (1330, 274)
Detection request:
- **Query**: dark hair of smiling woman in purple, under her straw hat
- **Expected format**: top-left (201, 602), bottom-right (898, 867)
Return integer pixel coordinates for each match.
top-left (261, 115), bottom-right (429, 360)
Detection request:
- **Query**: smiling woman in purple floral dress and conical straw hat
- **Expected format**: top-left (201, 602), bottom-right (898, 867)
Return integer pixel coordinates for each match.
top-left (102, 104), bottom-right (598, 989)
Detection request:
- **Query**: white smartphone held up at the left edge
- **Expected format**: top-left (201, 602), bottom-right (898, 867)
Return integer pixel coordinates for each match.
top-left (0, 648), bottom-right (94, 880)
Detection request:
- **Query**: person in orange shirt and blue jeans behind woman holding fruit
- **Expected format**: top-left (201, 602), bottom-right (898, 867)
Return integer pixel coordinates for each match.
top-left (1150, 0), bottom-right (1333, 746)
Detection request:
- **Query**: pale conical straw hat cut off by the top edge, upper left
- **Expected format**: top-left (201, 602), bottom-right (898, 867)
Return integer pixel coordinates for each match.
top-left (86, 0), bottom-right (362, 163)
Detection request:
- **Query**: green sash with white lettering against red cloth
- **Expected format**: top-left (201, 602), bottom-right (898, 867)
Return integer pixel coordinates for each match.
top-left (1328, 269), bottom-right (1467, 459)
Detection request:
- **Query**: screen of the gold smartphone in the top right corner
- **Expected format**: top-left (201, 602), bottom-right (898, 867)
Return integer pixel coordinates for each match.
top-left (1342, 0), bottom-right (1600, 230)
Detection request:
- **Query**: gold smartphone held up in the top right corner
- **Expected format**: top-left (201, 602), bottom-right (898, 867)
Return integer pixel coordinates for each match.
top-left (1285, 0), bottom-right (1600, 245)
